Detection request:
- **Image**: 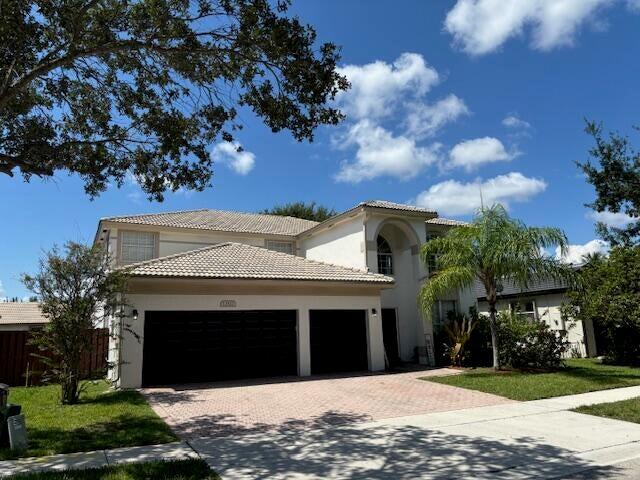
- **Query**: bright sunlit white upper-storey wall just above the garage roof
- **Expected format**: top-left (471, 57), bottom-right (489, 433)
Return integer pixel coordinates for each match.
top-left (300, 216), bottom-right (366, 270)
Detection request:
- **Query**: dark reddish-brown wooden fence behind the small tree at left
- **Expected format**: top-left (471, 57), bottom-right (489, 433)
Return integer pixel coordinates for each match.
top-left (0, 328), bottom-right (109, 386)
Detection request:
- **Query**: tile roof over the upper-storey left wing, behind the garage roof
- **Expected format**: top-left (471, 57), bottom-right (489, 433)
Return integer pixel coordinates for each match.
top-left (102, 209), bottom-right (318, 237)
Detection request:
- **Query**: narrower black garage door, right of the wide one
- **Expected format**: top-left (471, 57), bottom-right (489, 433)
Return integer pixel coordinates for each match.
top-left (309, 310), bottom-right (368, 374)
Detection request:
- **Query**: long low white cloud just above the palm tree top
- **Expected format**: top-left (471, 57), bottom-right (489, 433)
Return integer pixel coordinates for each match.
top-left (415, 172), bottom-right (547, 215)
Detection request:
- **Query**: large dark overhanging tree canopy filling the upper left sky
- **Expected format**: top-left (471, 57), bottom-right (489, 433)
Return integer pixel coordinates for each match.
top-left (0, 0), bottom-right (348, 200)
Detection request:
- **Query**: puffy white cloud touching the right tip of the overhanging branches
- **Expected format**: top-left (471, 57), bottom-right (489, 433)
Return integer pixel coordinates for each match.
top-left (337, 53), bottom-right (439, 119)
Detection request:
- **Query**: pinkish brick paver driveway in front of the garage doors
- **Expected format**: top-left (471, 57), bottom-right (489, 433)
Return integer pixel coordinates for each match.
top-left (143, 369), bottom-right (511, 438)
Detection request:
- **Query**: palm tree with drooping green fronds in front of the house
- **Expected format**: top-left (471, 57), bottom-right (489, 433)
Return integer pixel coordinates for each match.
top-left (419, 204), bottom-right (575, 369)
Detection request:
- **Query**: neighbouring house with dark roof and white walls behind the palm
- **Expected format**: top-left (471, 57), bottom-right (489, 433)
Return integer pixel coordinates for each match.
top-left (476, 279), bottom-right (596, 357)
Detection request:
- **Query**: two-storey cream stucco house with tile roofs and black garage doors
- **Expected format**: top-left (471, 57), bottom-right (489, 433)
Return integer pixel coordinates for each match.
top-left (95, 201), bottom-right (475, 387)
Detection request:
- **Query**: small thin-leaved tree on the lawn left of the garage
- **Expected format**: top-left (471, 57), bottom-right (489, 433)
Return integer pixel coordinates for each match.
top-left (22, 242), bottom-right (126, 404)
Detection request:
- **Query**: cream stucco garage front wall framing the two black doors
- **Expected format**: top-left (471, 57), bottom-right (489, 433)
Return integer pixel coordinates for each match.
top-left (112, 294), bottom-right (385, 388)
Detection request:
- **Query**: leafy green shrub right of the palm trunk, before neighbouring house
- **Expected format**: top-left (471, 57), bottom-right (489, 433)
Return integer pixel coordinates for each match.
top-left (498, 312), bottom-right (569, 369)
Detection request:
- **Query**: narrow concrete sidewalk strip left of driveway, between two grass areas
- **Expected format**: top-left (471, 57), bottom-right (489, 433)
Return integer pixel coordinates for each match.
top-left (0, 442), bottom-right (198, 477)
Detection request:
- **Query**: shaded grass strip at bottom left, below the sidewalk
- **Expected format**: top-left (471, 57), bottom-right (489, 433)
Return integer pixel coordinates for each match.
top-left (4, 460), bottom-right (220, 480)
